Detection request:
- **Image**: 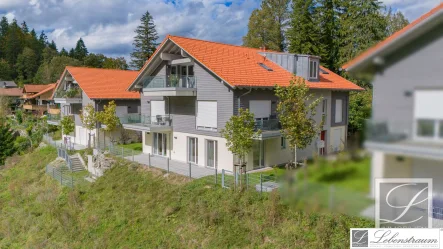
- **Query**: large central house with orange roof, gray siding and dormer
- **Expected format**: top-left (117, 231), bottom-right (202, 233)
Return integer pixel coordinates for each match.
top-left (124, 36), bottom-right (362, 170)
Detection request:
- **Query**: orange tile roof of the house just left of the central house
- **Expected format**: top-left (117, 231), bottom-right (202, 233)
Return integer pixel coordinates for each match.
top-left (66, 66), bottom-right (140, 99)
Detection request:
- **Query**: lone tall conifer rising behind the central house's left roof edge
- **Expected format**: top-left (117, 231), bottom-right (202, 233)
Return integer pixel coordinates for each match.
top-left (131, 11), bottom-right (158, 69)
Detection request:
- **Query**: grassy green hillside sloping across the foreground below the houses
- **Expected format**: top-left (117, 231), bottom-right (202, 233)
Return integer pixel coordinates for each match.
top-left (0, 147), bottom-right (373, 248)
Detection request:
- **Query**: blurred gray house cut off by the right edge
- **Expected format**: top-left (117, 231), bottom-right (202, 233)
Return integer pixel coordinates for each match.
top-left (343, 4), bottom-right (443, 195)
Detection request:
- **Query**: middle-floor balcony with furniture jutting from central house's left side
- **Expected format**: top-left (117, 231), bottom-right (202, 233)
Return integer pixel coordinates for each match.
top-left (119, 114), bottom-right (172, 132)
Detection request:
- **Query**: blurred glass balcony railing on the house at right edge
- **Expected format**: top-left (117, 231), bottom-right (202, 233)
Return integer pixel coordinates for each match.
top-left (365, 120), bottom-right (408, 143)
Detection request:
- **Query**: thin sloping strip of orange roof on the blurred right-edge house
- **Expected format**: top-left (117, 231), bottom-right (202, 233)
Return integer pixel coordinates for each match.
top-left (342, 3), bottom-right (443, 69)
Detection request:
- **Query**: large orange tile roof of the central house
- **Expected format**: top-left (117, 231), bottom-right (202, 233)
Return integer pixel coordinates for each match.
top-left (160, 36), bottom-right (363, 90)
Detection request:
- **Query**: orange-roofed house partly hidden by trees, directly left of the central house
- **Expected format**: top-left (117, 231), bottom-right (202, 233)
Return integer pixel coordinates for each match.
top-left (53, 66), bottom-right (140, 146)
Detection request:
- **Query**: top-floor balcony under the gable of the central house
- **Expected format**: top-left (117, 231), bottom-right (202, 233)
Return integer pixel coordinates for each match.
top-left (143, 75), bottom-right (197, 96)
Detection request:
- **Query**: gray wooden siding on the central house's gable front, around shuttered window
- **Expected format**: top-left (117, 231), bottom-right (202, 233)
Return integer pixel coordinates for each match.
top-left (169, 63), bottom-right (234, 136)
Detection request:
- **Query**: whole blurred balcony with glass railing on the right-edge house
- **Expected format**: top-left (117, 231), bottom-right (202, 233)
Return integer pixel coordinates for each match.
top-left (364, 120), bottom-right (443, 160)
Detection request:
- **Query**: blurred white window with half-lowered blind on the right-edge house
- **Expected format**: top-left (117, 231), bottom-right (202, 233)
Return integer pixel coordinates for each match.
top-left (414, 90), bottom-right (443, 140)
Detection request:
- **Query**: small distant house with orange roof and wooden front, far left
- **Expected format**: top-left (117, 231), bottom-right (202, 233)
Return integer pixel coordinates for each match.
top-left (22, 83), bottom-right (56, 115)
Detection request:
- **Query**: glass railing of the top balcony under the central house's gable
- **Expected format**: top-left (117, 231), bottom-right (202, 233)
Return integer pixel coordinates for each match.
top-left (143, 75), bottom-right (197, 89)
